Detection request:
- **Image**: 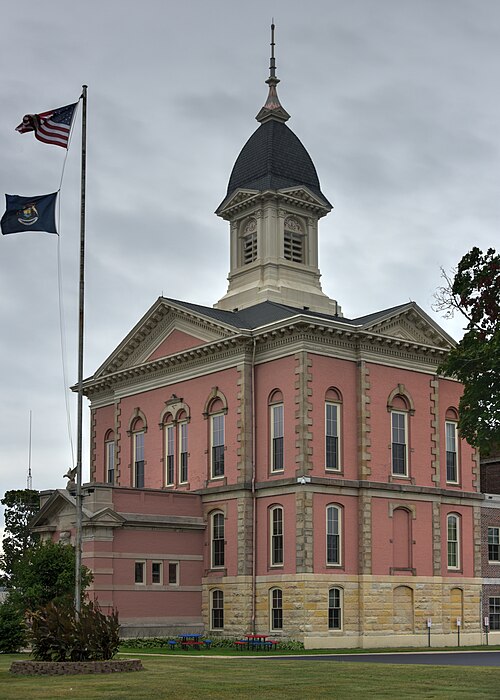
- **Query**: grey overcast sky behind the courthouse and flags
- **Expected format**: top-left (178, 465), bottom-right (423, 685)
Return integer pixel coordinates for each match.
top-left (0, 0), bottom-right (500, 532)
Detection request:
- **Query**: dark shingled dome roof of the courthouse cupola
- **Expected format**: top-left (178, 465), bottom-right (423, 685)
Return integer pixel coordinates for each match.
top-left (226, 119), bottom-right (329, 205)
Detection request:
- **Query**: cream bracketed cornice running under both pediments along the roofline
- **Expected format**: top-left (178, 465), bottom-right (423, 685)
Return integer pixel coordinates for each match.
top-left (83, 314), bottom-right (454, 407)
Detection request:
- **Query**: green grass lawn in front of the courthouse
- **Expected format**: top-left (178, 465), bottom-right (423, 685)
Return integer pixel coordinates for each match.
top-left (0, 653), bottom-right (500, 700)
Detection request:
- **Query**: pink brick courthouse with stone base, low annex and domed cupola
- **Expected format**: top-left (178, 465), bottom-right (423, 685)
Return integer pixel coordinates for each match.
top-left (31, 35), bottom-right (483, 648)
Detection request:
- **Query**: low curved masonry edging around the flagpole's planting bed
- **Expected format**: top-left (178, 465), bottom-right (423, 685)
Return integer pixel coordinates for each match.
top-left (10, 659), bottom-right (144, 676)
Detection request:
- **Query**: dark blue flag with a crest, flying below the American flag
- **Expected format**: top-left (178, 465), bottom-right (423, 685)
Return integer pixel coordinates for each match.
top-left (0, 192), bottom-right (57, 235)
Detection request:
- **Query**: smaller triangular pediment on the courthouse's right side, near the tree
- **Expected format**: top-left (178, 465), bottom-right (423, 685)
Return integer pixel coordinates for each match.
top-left (357, 302), bottom-right (455, 349)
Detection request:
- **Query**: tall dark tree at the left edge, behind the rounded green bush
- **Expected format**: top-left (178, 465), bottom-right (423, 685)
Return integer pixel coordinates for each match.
top-left (0, 489), bottom-right (40, 587)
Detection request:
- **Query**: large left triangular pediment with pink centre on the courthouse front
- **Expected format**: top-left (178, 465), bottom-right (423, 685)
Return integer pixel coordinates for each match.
top-left (93, 297), bottom-right (240, 379)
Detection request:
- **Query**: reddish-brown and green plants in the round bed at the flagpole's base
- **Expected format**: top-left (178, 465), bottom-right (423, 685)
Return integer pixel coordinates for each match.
top-left (30, 601), bottom-right (120, 661)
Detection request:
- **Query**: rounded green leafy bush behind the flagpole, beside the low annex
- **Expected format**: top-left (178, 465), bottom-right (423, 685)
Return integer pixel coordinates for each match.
top-left (10, 541), bottom-right (92, 611)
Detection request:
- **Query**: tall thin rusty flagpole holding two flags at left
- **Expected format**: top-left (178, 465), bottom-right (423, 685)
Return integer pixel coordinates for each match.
top-left (75, 85), bottom-right (87, 613)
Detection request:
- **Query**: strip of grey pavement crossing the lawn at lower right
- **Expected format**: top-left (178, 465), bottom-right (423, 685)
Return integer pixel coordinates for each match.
top-left (294, 651), bottom-right (500, 668)
